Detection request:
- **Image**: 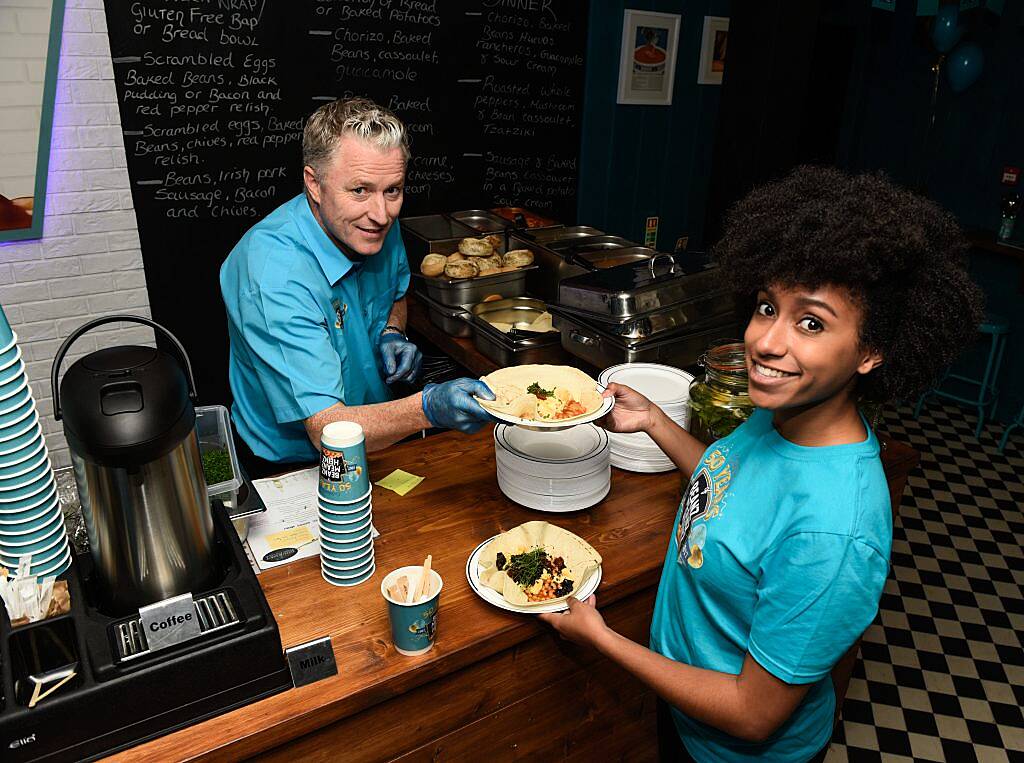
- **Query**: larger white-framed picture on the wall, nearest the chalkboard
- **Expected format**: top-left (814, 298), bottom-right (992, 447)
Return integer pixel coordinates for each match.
top-left (617, 8), bottom-right (681, 105)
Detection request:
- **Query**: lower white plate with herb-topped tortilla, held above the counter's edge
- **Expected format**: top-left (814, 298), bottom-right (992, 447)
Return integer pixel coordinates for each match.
top-left (466, 521), bottom-right (601, 614)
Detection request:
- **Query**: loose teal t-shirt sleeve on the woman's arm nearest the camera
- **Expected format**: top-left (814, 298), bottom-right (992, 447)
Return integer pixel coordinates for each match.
top-left (748, 533), bottom-right (889, 684)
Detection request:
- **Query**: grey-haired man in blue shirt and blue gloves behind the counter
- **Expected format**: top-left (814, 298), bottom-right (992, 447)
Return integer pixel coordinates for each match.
top-left (220, 98), bottom-right (494, 477)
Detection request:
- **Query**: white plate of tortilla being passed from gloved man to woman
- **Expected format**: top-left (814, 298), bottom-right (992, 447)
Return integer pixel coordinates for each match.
top-left (476, 365), bottom-right (615, 430)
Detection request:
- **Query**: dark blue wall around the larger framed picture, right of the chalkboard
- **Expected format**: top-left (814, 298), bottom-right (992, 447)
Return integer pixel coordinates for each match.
top-left (579, 0), bottom-right (729, 252)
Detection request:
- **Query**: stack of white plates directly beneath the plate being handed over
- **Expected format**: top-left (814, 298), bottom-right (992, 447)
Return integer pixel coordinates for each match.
top-left (495, 424), bottom-right (611, 512)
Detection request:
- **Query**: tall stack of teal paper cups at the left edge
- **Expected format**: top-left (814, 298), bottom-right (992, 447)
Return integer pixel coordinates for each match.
top-left (0, 309), bottom-right (72, 578)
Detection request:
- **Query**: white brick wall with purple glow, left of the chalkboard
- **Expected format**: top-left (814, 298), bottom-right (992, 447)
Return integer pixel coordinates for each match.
top-left (0, 0), bottom-right (153, 467)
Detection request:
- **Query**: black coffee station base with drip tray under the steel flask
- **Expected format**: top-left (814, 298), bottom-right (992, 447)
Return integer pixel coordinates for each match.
top-left (0, 504), bottom-right (292, 763)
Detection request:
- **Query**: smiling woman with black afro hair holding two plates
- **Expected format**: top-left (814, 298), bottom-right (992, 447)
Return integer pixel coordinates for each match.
top-left (541, 167), bottom-right (980, 761)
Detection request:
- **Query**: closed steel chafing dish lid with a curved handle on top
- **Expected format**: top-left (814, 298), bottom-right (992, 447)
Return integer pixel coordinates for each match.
top-left (558, 252), bottom-right (718, 320)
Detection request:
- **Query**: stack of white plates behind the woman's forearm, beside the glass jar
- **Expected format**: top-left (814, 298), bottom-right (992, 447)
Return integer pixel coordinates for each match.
top-left (598, 363), bottom-right (693, 472)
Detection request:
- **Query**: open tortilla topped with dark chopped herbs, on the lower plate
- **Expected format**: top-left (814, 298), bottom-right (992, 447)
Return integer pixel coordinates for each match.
top-left (479, 521), bottom-right (601, 606)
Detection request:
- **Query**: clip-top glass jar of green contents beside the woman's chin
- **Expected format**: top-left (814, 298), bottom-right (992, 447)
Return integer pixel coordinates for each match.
top-left (690, 342), bottom-right (754, 443)
